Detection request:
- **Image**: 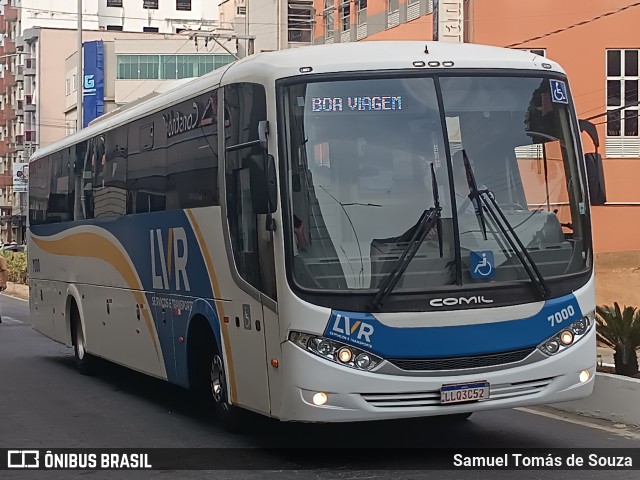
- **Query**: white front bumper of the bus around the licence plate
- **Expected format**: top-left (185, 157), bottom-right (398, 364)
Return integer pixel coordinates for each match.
top-left (277, 328), bottom-right (596, 422)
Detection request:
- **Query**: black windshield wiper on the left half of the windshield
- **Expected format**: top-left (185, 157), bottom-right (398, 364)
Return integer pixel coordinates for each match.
top-left (369, 163), bottom-right (443, 310)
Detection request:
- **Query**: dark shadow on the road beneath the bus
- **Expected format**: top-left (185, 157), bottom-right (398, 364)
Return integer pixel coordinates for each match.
top-left (43, 350), bottom-right (548, 452)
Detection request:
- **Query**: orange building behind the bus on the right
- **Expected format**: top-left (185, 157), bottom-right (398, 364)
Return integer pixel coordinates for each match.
top-left (314, 0), bottom-right (640, 252)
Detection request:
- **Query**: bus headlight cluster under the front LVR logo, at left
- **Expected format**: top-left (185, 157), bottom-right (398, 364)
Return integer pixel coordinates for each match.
top-left (289, 332), bottom-right (382, 371)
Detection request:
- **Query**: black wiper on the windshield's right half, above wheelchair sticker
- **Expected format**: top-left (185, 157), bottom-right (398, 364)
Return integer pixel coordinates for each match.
top-left (462, 150), bottom-right (551, 299)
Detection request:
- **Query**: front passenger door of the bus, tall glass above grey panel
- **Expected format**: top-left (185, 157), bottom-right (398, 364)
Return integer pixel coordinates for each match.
top-left (219, 83), bottom-right (280, 414)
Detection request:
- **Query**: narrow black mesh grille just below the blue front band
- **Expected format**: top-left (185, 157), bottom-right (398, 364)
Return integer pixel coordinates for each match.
top-left (388, 347), bottom-right (535, 371)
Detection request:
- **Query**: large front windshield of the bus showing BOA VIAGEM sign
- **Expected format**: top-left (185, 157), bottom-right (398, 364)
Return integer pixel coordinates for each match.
top-left (284, 74), bottom-right (589, 293)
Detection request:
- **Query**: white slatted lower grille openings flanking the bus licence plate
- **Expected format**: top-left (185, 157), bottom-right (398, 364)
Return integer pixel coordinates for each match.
top-left (360, 378), bottom-right (553, 408)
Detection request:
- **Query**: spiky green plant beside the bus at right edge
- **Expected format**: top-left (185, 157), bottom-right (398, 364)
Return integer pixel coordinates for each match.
top-left (596, 303), bottom-right (640, 375)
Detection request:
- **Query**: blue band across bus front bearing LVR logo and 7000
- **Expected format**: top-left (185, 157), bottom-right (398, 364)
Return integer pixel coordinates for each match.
top-left (324, 294), bottom-right (583, 358)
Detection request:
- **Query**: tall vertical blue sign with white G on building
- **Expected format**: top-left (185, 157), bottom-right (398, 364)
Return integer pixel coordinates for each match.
top-left (82, 40), bottom-right (104, 128)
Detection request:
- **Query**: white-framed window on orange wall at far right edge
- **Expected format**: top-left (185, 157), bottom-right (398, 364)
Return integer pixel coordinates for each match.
top-left (606, 49), bottom-right (640, 157)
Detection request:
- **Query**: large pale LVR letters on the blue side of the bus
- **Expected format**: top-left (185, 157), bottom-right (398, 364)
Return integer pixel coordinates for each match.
top-left (149, 227), bottom-right (191, 292)
